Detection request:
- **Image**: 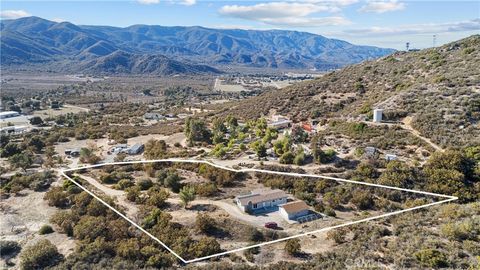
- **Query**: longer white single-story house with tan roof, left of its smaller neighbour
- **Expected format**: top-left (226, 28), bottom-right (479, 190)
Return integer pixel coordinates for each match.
top-left (235, 189), bottom-right (288, 212)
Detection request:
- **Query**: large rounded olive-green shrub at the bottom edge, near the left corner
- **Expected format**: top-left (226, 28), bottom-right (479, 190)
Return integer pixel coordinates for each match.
top-left (20, 239), bottom-right (61, 270)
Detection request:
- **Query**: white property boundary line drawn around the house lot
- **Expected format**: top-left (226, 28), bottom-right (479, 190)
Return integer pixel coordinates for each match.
top-left (60, 158), bottom-right (458, 264)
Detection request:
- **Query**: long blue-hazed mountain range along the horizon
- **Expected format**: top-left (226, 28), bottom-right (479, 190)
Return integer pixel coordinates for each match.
top-left (0, 17), bottom-right (394, 70)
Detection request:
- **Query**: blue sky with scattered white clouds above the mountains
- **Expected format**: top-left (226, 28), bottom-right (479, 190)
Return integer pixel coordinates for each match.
top-left (0, 0), bottom-right (480, 49)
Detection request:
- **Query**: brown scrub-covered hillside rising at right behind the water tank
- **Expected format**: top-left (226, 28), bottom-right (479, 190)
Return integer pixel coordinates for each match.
top-left (223, 35), bottom-right (480, 147)
